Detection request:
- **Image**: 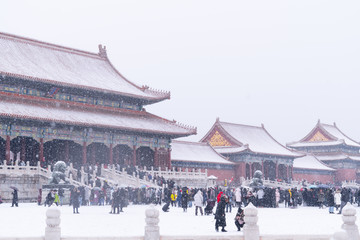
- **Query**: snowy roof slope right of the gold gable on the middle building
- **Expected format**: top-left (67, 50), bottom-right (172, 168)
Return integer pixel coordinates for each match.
top-left (212, 121), bottom-right (300, 157)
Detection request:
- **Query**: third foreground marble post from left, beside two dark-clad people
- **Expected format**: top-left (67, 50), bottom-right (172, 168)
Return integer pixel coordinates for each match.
top-left (244, 203), bottom-right (260, 240)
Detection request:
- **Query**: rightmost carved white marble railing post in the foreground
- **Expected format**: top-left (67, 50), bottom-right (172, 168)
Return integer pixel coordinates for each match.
top-left (341, 203), bottom-right (360, 240)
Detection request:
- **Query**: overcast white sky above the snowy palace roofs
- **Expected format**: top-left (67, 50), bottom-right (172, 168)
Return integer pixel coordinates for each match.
top-left (0, 0), bottom-right (360, 144)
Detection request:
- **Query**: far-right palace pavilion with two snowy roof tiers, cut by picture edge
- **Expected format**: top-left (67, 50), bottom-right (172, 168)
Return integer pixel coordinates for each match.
top-left (287, 121), bottom-right (360, 183)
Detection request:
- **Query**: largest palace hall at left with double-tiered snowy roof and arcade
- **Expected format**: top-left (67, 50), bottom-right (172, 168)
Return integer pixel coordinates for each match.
top-left (0, 33), bottom-right (196, 167)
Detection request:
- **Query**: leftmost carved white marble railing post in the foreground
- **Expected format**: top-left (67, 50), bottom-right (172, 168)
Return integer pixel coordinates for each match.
top-left (45, 207), bottom-right (61, 240)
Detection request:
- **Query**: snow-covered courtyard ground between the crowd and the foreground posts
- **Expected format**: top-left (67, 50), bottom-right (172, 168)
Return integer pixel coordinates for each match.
top-left (0, 203), bottom-right (352, 237)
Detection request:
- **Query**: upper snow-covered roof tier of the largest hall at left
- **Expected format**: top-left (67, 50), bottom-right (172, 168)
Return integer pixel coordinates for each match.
top-left (0, 32), bottom-right (170, 102)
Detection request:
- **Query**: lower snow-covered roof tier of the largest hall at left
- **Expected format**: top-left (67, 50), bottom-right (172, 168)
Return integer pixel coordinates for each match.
top-left (0, 94), bottom-right (196, 137)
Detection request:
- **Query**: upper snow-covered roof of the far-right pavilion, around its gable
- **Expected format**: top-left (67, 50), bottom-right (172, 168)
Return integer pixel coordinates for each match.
top-left (287, 121), bottom-right (360, 147)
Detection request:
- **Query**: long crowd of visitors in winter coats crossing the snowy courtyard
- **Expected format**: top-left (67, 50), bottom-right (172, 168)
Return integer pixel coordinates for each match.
top-left (6, 178), bottom-right (360, 232)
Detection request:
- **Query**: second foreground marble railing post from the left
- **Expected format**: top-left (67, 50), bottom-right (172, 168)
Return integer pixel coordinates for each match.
top-left (144, 207), bottom-right (160, 240)
